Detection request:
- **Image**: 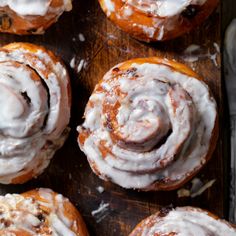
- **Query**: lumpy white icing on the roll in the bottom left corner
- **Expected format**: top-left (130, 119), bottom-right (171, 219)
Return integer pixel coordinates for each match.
top-left (0, 189), bottom-right (76, 236)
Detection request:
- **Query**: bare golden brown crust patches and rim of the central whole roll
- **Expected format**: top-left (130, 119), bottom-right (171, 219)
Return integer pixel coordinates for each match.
top-left (78, 57), bottom-right (219, 191)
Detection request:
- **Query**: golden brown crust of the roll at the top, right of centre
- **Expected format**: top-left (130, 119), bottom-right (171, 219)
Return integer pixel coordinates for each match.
top-left (99, 0), bottom-right (219, 42)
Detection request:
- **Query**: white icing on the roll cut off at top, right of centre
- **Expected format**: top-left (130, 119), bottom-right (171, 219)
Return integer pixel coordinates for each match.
top-left (126, 0), bottom-right (206, 17)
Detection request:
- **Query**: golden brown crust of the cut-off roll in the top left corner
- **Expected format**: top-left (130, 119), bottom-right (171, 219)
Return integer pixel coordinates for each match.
top-left (0, 0), bottom-right (71, 35)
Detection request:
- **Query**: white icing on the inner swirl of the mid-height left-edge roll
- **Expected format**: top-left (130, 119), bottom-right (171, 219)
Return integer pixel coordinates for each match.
top-left (0, 62), bottom-right (48, 138)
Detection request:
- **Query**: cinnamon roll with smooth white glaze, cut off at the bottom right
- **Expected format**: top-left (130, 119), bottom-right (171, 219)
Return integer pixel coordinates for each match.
top-left (129, 207), bottom-right (236, 236)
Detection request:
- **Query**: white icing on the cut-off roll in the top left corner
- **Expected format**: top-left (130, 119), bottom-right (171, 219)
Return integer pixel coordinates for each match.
top-left (0, 0), bottom-right (72, 16)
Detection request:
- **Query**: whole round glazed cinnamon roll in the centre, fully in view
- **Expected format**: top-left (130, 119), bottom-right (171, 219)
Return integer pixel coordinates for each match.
top-left (78, 58), bottom-right (218, 191)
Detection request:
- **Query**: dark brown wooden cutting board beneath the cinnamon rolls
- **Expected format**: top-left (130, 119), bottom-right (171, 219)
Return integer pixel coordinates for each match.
top-left (0, 0), bottom-right (229, 236)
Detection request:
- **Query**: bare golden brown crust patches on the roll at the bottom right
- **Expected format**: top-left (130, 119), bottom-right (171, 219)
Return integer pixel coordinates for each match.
top-left (129, 206), bottom-right (236, 236)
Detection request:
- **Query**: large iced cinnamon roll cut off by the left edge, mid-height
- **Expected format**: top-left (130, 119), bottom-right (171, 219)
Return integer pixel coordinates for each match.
top-left (0, 43), bottom-right (71, 184)
